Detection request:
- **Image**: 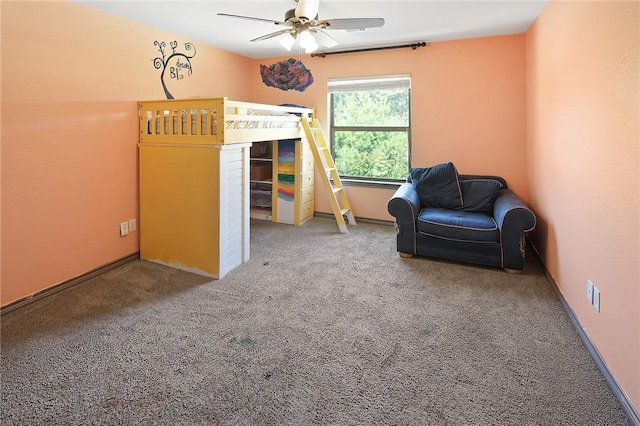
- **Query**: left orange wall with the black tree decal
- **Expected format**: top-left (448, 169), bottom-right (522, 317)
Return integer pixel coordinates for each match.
top-left (0, 1), bottom-right (252, 305)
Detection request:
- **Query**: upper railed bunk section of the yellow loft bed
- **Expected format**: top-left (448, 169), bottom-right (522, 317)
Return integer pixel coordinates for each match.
top-left (139, 98), bottom-right (314, 145)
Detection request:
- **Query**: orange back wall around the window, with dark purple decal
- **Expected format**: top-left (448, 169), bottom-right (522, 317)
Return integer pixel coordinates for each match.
top-left (251, 34), bottom-right (528, 220)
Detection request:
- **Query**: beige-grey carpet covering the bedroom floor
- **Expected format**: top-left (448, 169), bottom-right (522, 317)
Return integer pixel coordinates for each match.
top-left (1, 218), bottom-right (628, 425)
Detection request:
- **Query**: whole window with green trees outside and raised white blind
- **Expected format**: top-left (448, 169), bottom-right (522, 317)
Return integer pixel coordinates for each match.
top-left (328, 75), bottom-right (411, 181)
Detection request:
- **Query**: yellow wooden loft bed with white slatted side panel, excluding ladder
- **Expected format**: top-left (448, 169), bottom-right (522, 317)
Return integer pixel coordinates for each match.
top-left (138, 98), bottom-right (314, 279)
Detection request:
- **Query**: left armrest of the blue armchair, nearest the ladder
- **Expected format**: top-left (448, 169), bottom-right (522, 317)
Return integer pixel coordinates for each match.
top-left (387, 182), bottom-right (420, 254)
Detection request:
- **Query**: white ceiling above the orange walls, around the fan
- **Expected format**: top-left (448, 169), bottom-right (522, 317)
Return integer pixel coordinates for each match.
top-left (76, 0), bottom-right (548, 59)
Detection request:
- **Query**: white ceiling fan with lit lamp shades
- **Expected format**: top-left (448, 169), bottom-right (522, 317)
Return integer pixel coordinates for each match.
top-left (218, 0), bottom-right (384, 53)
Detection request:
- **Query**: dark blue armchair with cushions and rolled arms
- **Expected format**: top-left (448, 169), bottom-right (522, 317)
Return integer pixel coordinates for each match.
top-left (387, 163), bottom-right (536, 273)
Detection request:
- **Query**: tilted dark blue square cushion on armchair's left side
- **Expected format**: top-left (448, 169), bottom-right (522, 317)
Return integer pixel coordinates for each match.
top-left (409, 162), bottom-right (462, 209)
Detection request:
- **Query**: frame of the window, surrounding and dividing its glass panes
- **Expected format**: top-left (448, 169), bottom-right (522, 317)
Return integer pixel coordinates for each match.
top-left (327, 74), bottom-right (412, 187)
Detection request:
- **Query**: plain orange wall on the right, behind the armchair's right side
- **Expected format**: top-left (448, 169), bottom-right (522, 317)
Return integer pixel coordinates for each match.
top-left (526, 1), bottom-right (640, 411)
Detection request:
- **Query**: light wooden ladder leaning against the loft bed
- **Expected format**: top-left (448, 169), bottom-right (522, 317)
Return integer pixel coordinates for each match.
top-left (300, 117), bottom-right (357, 234)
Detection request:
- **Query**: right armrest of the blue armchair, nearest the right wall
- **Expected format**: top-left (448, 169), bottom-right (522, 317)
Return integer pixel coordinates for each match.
top-left (493, 189), bottom-right (536, 271)
